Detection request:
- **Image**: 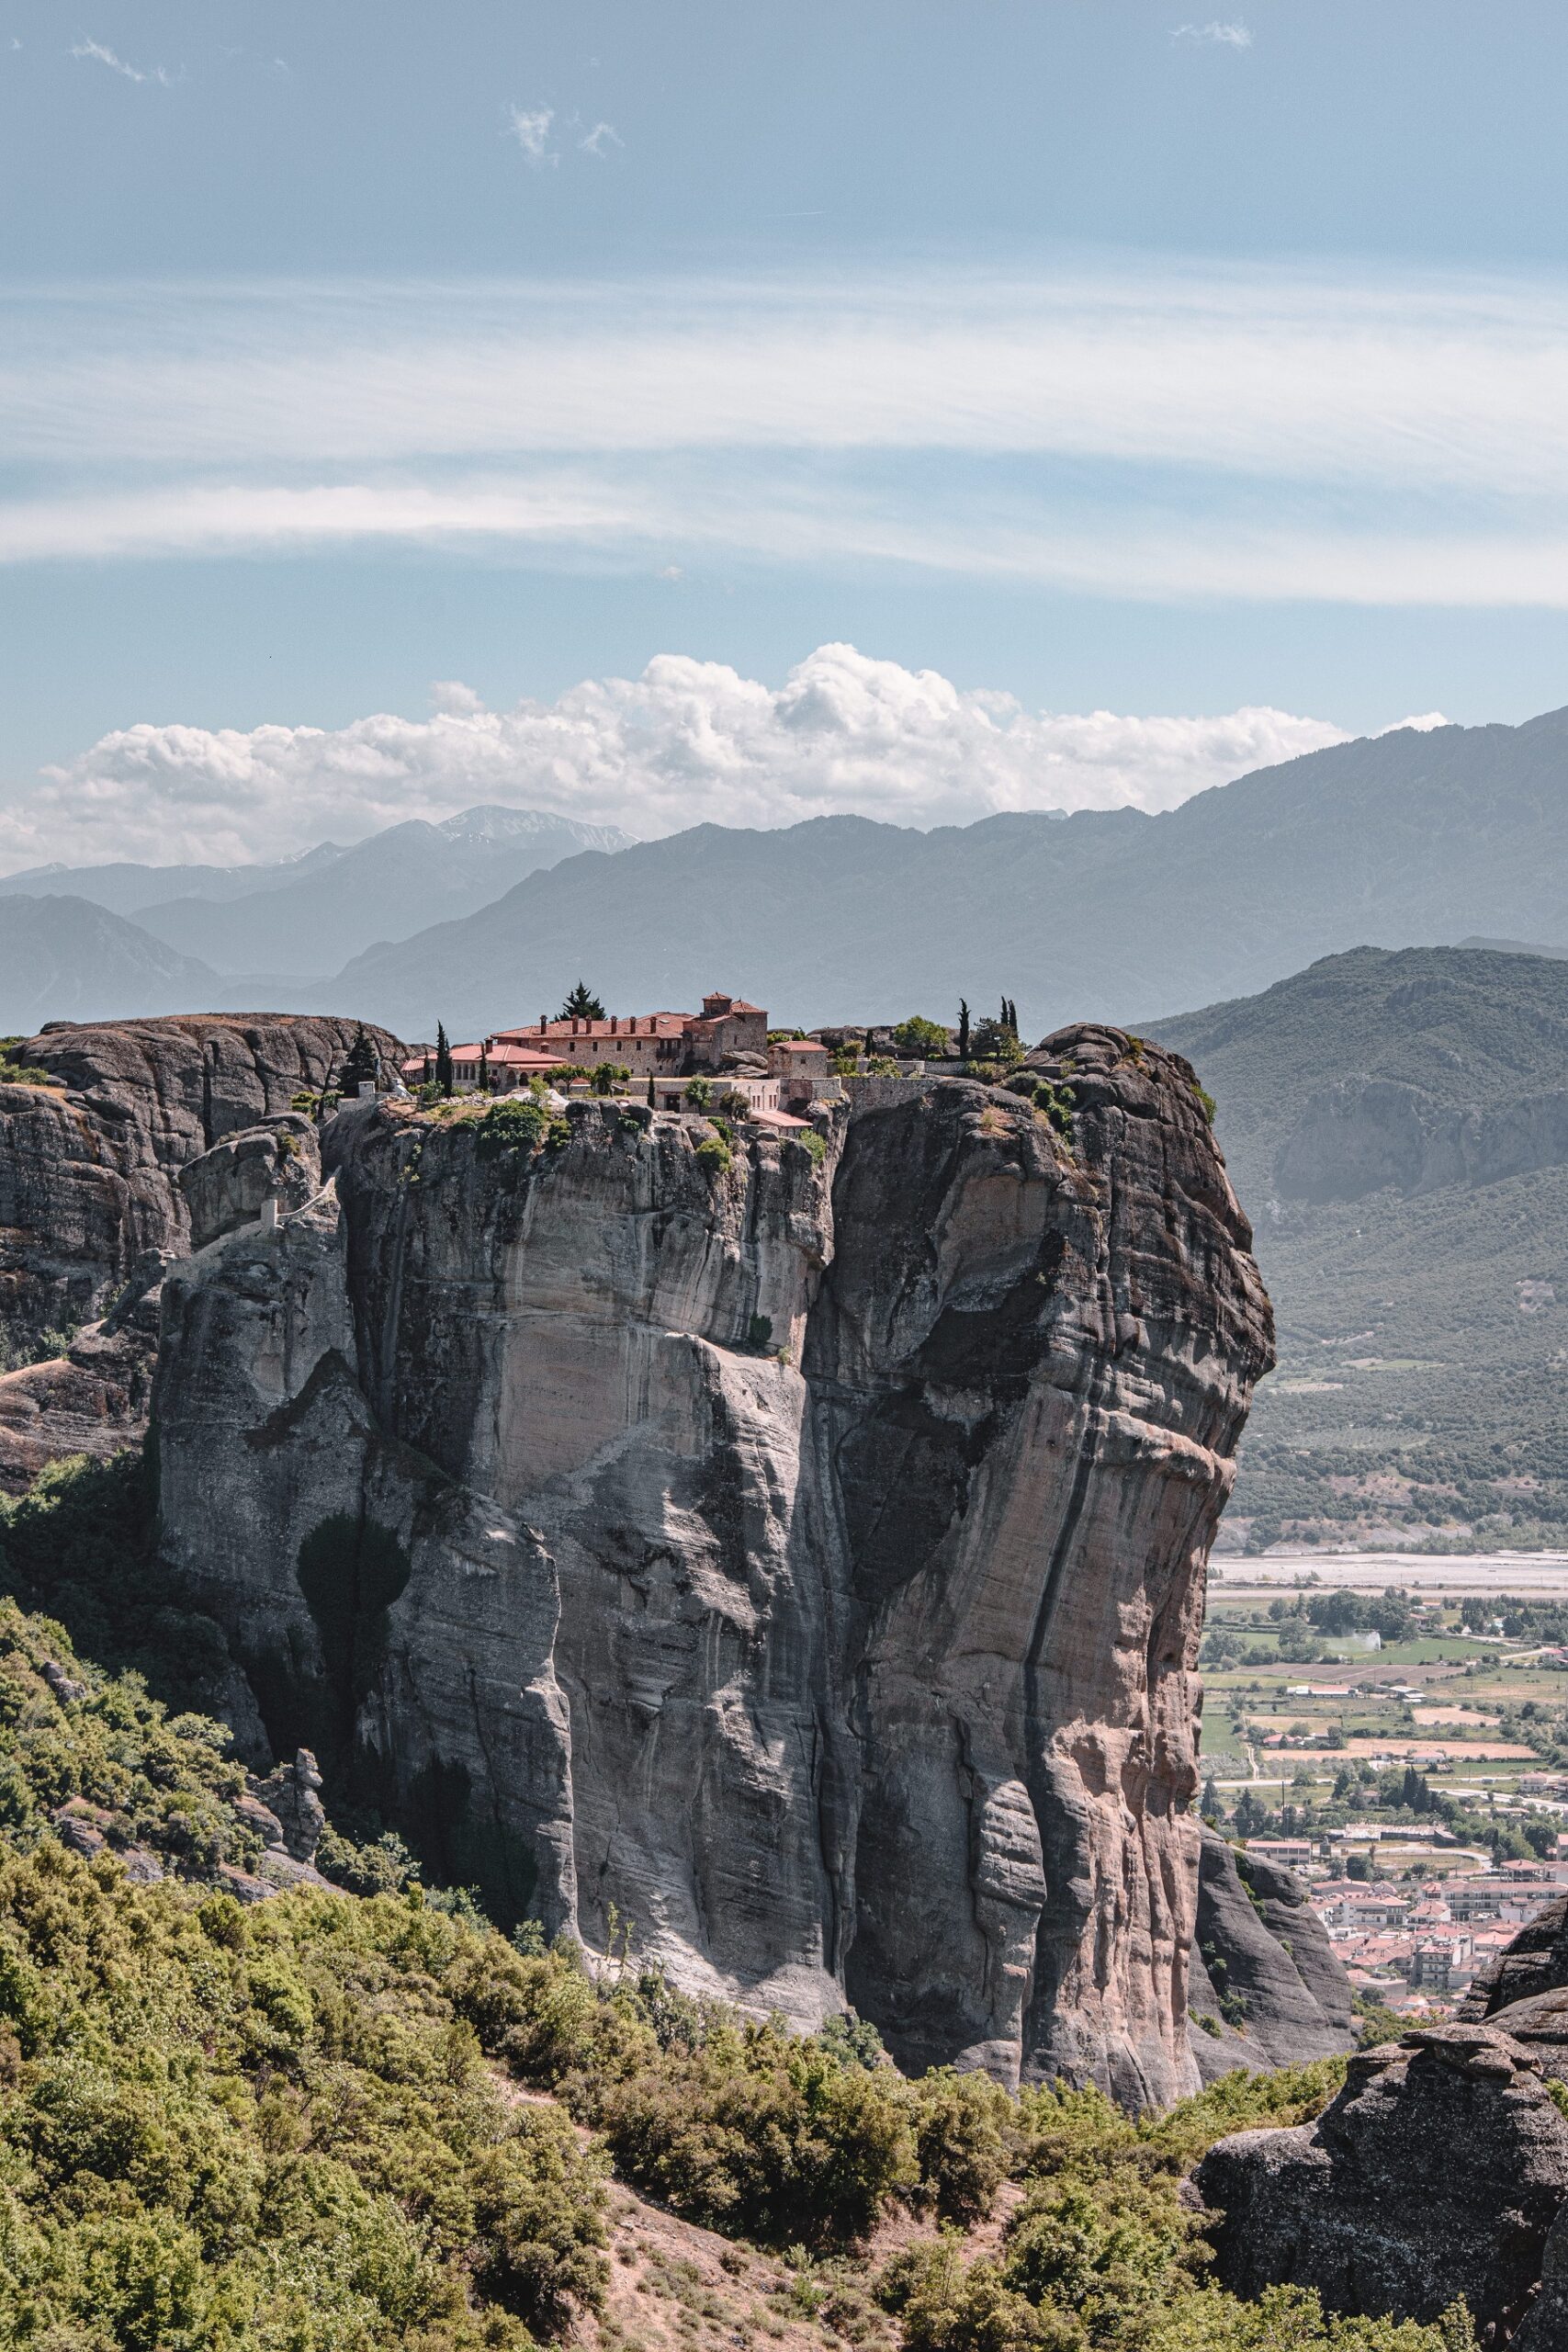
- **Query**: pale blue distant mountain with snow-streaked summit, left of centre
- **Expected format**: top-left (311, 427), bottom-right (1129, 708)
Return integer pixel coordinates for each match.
top-left (0, 807), bottom-right (632, 974)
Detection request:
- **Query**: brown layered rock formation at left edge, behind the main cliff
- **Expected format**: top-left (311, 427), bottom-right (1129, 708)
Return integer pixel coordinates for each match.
top-left (0, 1013), bottom-right (402, 1491)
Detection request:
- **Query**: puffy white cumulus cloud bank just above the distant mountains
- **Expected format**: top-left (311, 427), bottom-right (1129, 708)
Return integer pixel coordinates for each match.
top-left (0, 644), bottom-right (1345, 870)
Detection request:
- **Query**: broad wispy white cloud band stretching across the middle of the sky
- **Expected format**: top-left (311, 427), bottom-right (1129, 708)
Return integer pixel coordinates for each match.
top-left (0, 266), bottom-right (1568, 609)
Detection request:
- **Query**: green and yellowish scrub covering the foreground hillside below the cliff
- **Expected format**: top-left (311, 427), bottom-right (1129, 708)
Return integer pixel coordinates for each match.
top-left (0, 1561), bottom-right (1472, 2352)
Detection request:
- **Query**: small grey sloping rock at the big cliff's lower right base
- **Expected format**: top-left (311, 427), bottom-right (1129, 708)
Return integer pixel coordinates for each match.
top-left (1187, 1826), bottom-right (1357, 2082)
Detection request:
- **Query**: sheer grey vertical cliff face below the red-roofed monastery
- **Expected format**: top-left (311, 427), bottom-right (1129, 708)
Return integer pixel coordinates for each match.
top-left (155, 1028), bottom-right (1269, 2100)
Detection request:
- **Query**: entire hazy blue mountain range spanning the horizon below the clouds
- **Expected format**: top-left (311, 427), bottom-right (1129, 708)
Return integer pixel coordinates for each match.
top-left (0, 710), bottom-right (1568, 1037)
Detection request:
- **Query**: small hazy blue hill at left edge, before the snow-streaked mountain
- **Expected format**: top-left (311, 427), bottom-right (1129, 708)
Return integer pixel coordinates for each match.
top-left (0, 899), bottom-right (221, 1037)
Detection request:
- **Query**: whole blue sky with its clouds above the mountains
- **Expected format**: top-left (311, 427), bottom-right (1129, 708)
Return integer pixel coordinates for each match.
top-left (0, 0), bottom-right (1568, 868)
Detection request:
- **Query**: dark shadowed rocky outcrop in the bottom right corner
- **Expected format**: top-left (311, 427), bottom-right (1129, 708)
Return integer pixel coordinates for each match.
top-left (1194, 2025), bottom-right (1568, 2345)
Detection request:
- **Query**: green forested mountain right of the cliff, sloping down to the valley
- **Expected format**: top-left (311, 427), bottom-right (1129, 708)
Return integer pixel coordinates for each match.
top-left (1149, 948), bottom-right (1568, 1545)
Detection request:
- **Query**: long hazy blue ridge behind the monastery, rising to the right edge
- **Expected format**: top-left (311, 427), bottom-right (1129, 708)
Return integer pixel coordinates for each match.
top-left (329, 710), bottom-right (1568, 1035)
